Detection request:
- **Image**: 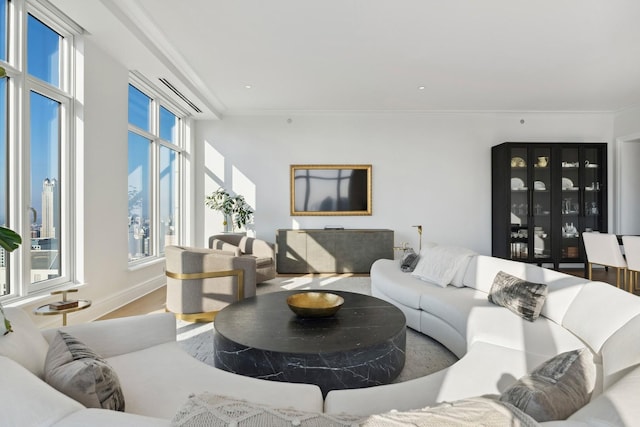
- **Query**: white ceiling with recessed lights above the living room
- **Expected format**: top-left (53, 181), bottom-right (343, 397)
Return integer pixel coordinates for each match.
top-left (52, 0), bottom-right (640, 118)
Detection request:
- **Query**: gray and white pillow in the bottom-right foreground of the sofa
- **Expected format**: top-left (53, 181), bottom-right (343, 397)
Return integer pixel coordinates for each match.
top-left (500, 348), bottom-right (596, 422)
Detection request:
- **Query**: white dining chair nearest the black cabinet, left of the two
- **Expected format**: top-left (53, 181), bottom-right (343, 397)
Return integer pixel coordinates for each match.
top-left (582, 232), bottom-right (627, 289)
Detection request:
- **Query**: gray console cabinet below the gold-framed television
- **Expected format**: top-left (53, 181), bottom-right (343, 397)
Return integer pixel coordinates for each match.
top-left (276, 229), bottom-right (393, 273)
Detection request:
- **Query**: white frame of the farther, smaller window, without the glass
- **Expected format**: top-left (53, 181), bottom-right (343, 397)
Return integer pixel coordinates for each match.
top-left (127, 72), bottom-right (184, 269)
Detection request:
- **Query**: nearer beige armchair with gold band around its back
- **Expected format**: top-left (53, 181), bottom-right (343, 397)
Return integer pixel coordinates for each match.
top-left (165, 246), bottom-right (256, 322)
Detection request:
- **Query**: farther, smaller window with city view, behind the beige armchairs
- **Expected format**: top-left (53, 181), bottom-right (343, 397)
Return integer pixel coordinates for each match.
top-left (128, 78), bottom-right (184, 262)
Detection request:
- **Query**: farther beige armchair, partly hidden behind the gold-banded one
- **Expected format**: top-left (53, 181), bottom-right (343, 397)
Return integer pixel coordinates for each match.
top-left (209, 234), bottom-right (276, 283)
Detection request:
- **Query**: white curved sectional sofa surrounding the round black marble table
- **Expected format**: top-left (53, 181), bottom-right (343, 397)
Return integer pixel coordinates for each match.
top-left (0, 252), bottom-right (640, 427)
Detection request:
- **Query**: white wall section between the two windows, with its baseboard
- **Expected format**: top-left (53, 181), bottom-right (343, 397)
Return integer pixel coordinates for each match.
top-left (24, 39), bottom-right (165, 326)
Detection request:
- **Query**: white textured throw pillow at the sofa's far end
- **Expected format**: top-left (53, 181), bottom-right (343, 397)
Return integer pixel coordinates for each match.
top-left (411, 246), bottom-right (475, 288)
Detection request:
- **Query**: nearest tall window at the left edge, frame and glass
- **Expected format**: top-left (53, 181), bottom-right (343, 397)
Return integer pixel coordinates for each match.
top-left (0, 0), bottom-right (77, 297)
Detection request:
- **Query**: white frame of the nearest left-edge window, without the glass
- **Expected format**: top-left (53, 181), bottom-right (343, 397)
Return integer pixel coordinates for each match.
top-left (0, 0), bottom-right (82, 301)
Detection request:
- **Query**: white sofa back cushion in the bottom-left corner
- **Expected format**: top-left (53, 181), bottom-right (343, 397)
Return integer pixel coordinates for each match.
top-left (0, 356), bottom-right (84, 426)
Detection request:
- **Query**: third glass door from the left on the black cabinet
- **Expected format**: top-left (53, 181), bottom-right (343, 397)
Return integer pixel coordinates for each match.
top-left (560, 146), bottom-right (583, 261)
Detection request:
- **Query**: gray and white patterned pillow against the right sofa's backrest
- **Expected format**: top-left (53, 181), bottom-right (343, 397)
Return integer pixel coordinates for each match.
top-left (489, 271), bottom-right (549, 322)
